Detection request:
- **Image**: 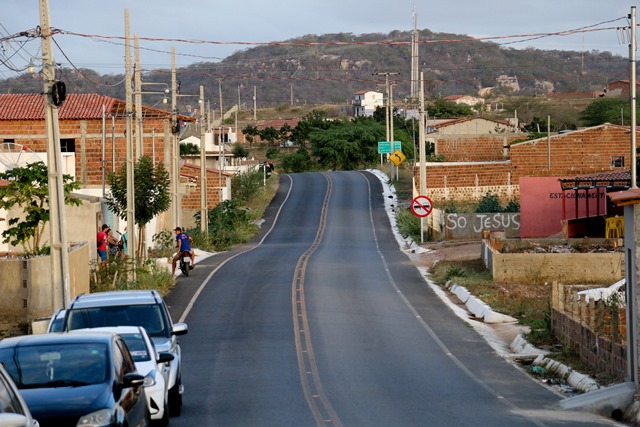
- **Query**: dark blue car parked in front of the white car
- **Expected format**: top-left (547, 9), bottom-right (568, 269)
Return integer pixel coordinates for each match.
top-left (0, 332), bottom-right (150, 427)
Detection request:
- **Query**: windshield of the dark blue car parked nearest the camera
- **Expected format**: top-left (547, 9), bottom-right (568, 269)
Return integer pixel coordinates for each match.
top-left (0, 343), bottom-right (108, 389)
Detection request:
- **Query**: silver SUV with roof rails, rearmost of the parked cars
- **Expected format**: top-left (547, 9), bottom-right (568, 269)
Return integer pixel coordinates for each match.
top-left (62, 290), bottom-right (189, 416)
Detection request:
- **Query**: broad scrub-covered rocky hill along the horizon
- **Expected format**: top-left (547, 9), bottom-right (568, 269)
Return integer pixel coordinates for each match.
top-left (0, 29), bottom-right (628, 111)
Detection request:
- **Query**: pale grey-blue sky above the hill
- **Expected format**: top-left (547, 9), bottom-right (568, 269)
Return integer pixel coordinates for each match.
top-left (0, 0), bottom-right (635, 79)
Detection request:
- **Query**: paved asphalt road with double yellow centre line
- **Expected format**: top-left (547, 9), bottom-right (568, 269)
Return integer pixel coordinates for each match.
top-left (167, 171), bottom-right (615, 427)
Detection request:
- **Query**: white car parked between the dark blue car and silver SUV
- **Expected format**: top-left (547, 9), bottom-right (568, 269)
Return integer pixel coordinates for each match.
top-left (78, 326), bottom-right (173, 427)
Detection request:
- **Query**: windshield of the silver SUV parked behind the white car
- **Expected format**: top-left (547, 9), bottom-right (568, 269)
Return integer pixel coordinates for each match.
top-left (67, 304), bottom-right (171, 337)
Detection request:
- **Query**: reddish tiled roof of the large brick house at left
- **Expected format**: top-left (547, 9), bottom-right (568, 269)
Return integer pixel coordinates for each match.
top-left (0, 93), bottom-right (194, 122)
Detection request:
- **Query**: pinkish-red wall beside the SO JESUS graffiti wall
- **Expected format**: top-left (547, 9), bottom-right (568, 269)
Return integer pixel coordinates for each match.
top-left (520, 176), bottom-right (606, 239)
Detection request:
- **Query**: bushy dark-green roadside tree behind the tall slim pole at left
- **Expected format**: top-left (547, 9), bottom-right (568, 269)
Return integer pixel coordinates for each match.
top-left (106, 156), bottom-right (171, 253)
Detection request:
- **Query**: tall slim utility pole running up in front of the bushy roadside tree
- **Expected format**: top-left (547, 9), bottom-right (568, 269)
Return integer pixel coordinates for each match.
top-left (124, 9), bottom-right (137, 281)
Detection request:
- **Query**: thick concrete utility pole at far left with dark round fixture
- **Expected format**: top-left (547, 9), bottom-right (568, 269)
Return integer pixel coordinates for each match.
top-left (40, 0), bottom-right (70, 311)
